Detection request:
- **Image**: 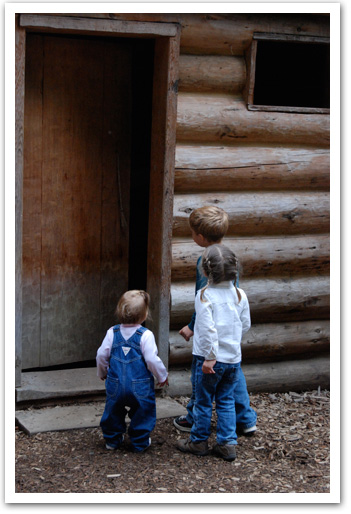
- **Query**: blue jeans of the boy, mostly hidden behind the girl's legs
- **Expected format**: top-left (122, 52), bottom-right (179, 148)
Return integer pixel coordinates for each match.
top-left (186, 355), bottom-right (257, 429)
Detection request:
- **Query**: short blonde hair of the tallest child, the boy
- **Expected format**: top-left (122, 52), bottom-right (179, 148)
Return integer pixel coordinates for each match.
top-left (189, 205), bottom-right (229, 243)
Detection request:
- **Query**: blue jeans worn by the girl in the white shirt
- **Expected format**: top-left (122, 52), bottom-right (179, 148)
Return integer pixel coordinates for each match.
top-left (190, 357), bottom-right (240, 445)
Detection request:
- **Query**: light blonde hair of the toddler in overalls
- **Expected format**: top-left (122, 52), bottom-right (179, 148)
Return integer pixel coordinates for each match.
top-left (116, 289), bottom-right (150, 325)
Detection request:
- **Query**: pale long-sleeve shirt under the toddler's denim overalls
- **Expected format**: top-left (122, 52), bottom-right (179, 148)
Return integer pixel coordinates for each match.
top-left (96, 325), bottom-right (168, 383)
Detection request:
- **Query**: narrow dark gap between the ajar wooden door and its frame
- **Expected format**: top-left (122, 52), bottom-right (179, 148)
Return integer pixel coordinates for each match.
top-left (128, 40), bottom-right (154, 290)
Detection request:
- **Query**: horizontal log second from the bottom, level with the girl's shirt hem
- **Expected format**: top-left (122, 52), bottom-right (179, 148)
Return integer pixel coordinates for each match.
top-left (169, 320), bottom-right (330, 366)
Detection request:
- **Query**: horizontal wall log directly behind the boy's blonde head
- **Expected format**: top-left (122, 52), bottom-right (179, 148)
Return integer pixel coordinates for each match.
top-left (173, 192), bottom-right (330, 237)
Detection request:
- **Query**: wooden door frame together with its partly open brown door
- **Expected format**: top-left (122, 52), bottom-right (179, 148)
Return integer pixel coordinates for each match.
top-left (15, 13), bottom-right (181, 380)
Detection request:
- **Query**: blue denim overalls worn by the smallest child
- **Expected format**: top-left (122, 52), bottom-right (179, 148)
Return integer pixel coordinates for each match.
top-left (100, 325), bottom-right (156, 452)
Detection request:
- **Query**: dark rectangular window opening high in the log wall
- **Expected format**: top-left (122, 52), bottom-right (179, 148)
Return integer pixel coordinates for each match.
top-left (247, 35), bottom-right (330, 112)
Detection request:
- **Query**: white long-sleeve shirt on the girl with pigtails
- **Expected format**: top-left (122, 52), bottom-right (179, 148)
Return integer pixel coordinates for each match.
top-left (193, 282), bottom-right (251, 364)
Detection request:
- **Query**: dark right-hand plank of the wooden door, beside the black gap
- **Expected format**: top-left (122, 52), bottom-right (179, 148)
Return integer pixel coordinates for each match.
top-left (100, 40), bottom-right (132, 336)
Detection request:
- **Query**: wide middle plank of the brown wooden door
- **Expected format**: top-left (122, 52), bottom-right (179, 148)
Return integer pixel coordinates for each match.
top-left (40, 36), bottom-right (103, 366)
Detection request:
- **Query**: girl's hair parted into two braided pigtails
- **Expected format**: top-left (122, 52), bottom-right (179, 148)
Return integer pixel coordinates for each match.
top-left (200, 244), bottom-right (241, 303)
